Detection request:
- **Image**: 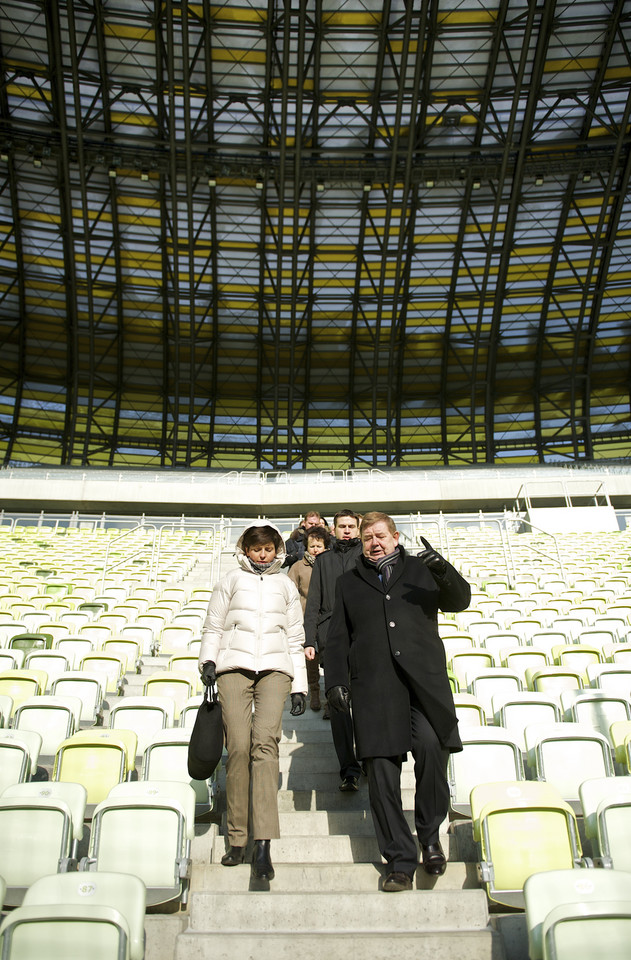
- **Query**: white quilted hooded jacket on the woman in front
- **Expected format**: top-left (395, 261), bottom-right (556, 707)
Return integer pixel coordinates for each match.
top-left (199, 523), bottom-right (308, 693)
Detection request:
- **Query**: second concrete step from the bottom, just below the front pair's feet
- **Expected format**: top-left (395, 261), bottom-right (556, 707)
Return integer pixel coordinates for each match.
top-left (189, 888), bottom-right (489, 936)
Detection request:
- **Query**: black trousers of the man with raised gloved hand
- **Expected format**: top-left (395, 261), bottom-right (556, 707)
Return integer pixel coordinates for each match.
top-left (366, 704), bottom-right (449, 875)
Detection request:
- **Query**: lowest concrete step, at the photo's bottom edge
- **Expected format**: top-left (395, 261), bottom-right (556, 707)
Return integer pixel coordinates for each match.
top-left (174, 928), bottom-right (504, 960)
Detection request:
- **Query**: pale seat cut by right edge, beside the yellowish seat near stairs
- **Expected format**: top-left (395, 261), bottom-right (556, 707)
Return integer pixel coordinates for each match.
top-left (579, 776), bottom-right (631, 871)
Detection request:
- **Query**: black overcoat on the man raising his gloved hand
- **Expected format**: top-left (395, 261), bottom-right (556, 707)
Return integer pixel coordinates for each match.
top-left (324, 547), bottom-right (471, 759)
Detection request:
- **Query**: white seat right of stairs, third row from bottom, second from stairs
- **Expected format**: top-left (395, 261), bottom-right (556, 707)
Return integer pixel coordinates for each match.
top-left (524, 723), bottom-right (615, 810)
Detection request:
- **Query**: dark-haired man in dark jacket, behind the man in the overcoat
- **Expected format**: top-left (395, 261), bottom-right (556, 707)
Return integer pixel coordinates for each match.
top-left (305, 510), bottom-right (362, 793)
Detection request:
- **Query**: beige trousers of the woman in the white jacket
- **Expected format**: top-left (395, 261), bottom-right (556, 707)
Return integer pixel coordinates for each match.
top-left (217, 670), bottom-right (291, 847)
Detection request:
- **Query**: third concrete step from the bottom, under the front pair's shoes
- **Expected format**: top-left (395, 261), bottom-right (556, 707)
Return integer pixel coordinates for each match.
top-left (191, 860), bottom-right (480, 893)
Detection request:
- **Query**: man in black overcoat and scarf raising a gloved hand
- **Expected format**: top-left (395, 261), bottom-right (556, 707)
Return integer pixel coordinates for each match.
top-left (324, 513), bottom-right (471, 892)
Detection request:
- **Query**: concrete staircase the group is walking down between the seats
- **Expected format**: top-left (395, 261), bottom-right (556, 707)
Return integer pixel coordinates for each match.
top-left (141, 552), bottom-right (527, 960)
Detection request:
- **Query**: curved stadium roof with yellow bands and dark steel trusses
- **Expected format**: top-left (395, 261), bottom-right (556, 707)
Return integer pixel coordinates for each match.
top-left (0, 0), bottom-right (631, 470)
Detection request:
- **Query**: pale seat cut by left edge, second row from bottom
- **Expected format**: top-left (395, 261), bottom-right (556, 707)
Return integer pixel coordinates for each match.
top-left (0, 782), bottom-right (86, 907)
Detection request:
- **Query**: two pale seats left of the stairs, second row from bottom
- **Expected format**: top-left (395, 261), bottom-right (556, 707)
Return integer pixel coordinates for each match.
top-left (0, 779), bottom-right (195, 906)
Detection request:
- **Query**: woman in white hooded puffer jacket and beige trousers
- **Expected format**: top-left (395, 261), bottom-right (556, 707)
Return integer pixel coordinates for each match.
top-left (199, 521), bottom-right (307, 880)
